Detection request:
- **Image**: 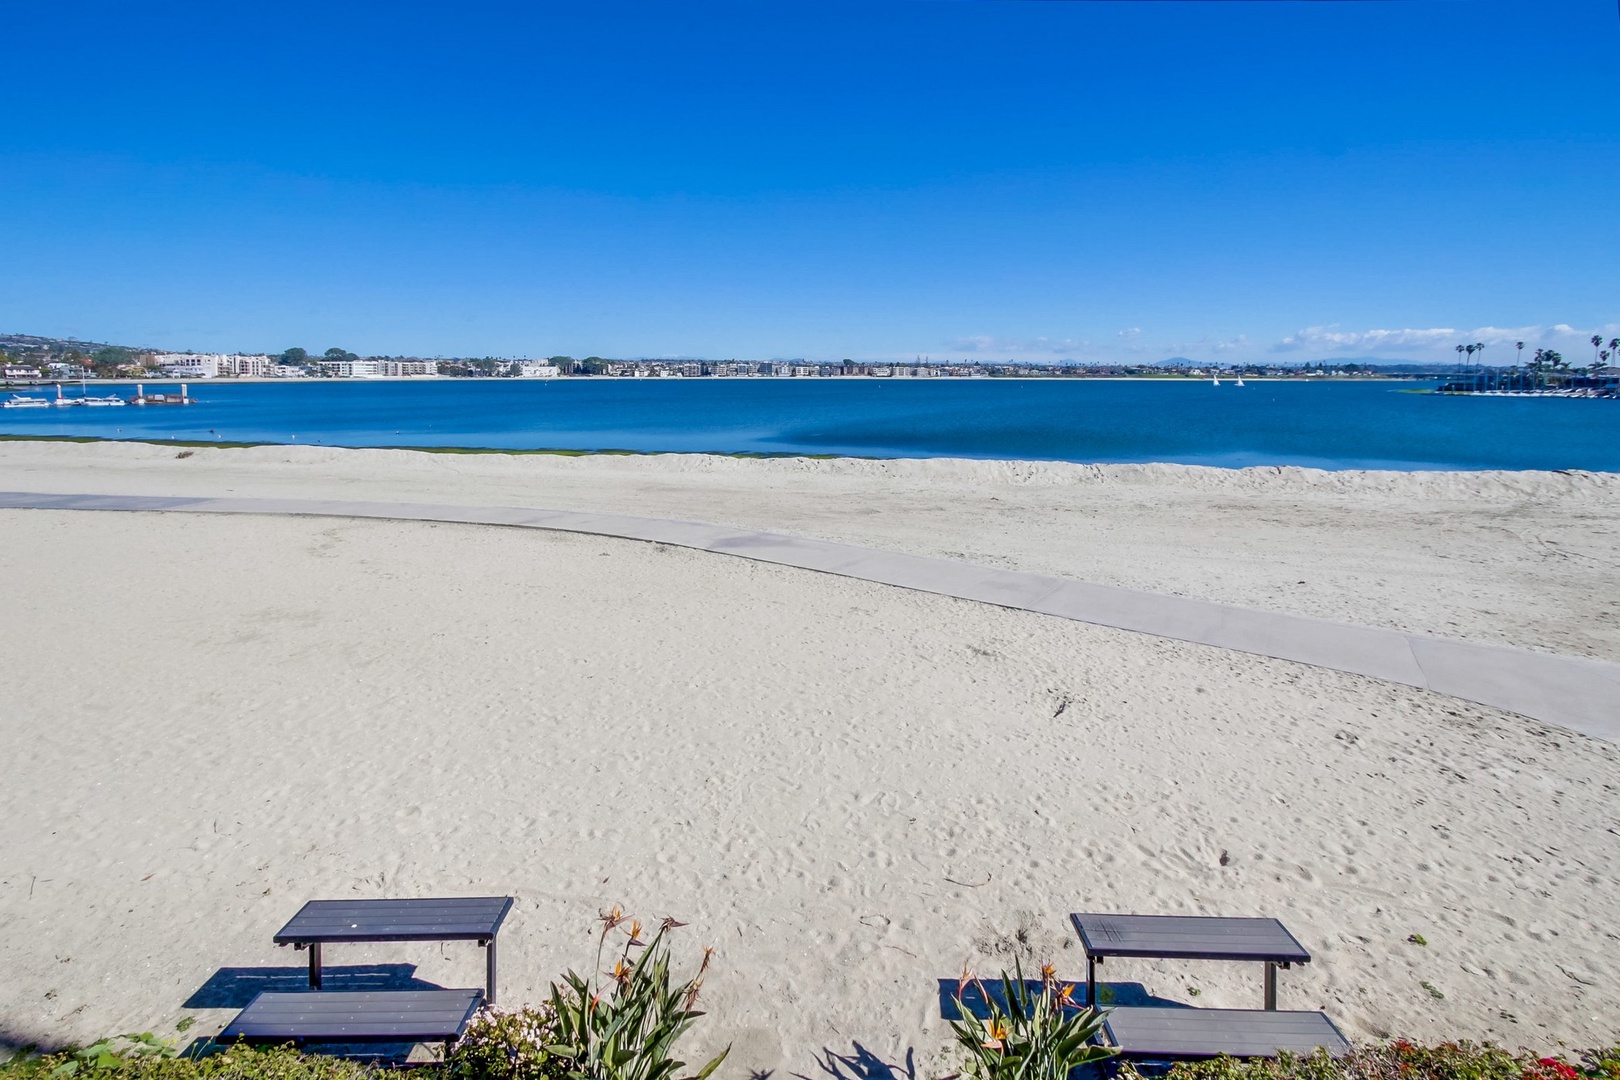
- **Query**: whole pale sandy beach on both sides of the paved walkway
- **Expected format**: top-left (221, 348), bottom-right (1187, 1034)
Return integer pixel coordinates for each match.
top-left (0, 442), bottom-right (1620, 1078)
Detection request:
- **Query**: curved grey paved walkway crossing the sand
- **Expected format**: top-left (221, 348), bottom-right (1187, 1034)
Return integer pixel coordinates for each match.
top-left (0, 492), bottom-right (1620, 740)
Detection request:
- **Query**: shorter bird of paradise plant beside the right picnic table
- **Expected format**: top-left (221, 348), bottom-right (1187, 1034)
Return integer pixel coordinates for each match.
top-left (951, 959), bottom-right (1115, 1080)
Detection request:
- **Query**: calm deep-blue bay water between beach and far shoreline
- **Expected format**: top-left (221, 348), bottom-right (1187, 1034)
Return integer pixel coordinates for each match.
top-left (0, 379), bottom-right (1620, 471)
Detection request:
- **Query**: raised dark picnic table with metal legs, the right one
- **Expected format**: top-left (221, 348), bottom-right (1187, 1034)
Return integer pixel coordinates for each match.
top-left (1069, 913), bottom-right (1311, 1012)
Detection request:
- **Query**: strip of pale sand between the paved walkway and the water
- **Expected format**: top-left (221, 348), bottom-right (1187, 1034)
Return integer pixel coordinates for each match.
top-left (0, 442), bottom-right (1620, 661)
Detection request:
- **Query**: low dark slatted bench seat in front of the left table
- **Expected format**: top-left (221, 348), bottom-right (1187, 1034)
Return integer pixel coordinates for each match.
top-left (214, 989), bottom-right (484, 1046)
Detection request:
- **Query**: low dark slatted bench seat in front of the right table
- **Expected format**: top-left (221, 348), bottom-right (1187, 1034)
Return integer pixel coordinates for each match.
top-left (1103, 1007), bottom-right (1349, 1061)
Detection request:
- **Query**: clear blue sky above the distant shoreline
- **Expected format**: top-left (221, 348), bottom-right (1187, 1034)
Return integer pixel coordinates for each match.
top-left (0, 0), bottom-right (1620, 361)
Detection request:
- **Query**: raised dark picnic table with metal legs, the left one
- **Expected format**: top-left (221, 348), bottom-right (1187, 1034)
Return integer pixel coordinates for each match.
top-left (272, 897), bottom-right (512, 1018)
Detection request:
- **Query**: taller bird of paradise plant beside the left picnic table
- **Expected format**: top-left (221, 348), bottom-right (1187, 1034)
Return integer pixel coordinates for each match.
top-left (546, 907), bottom-right (731, 1080)
